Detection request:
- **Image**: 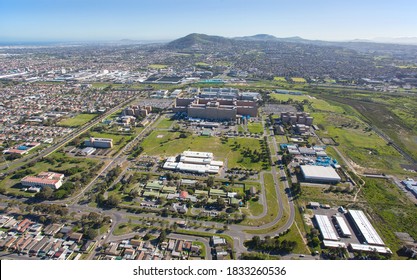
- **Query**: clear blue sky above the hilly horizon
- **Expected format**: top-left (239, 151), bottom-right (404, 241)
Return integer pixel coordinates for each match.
top-left (0, 0), bottom-right (417, 41)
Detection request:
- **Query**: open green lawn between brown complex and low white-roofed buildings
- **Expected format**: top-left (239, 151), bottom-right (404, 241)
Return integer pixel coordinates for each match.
top-left (142, 131), bottom-right (262, 170)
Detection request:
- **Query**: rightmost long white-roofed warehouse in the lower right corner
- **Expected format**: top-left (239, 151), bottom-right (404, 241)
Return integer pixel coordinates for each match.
top-left (348, 210), bottom-right (385, 246)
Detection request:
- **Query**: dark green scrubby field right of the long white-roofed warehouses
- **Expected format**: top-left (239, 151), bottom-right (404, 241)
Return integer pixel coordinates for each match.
top-left (360, 178), bottom-right (417, 260)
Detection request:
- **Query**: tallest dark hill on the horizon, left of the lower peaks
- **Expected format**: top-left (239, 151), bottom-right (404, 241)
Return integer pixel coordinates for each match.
top-left (166, 33), bottom-right (233, 49)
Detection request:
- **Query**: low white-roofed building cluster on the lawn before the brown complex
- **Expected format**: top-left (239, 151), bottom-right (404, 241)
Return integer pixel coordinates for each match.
top-left (163, 151), bottom-right (223, 174)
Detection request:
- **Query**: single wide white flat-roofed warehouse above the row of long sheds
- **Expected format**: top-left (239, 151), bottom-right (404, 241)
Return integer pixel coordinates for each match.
top-left (300, 165), bottom-right (341, 184)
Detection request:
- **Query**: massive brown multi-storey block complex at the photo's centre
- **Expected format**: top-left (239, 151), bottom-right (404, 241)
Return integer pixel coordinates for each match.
top-left (173, 98), bottom-right (258, 120)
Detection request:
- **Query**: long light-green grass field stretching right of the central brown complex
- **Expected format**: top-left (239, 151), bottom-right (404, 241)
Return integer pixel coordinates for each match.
top-left (271, 94), bottom-right (407, 174)
